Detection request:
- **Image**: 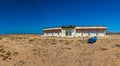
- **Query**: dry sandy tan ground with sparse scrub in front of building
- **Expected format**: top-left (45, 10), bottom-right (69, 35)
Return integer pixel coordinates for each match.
top-left (0, 35), bottom-right (120, 66)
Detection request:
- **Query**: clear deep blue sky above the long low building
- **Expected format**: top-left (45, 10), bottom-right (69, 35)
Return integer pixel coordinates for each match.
top-left (0, 0), bottom-right (120, 34)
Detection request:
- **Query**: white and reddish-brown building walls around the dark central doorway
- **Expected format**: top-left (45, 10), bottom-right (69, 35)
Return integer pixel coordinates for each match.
top-left (44, 28), bottom-right (106, 37)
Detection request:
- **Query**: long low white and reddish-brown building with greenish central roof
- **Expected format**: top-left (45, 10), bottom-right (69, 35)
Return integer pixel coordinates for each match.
top-left (43, 26), bottom-right (107, 37)
